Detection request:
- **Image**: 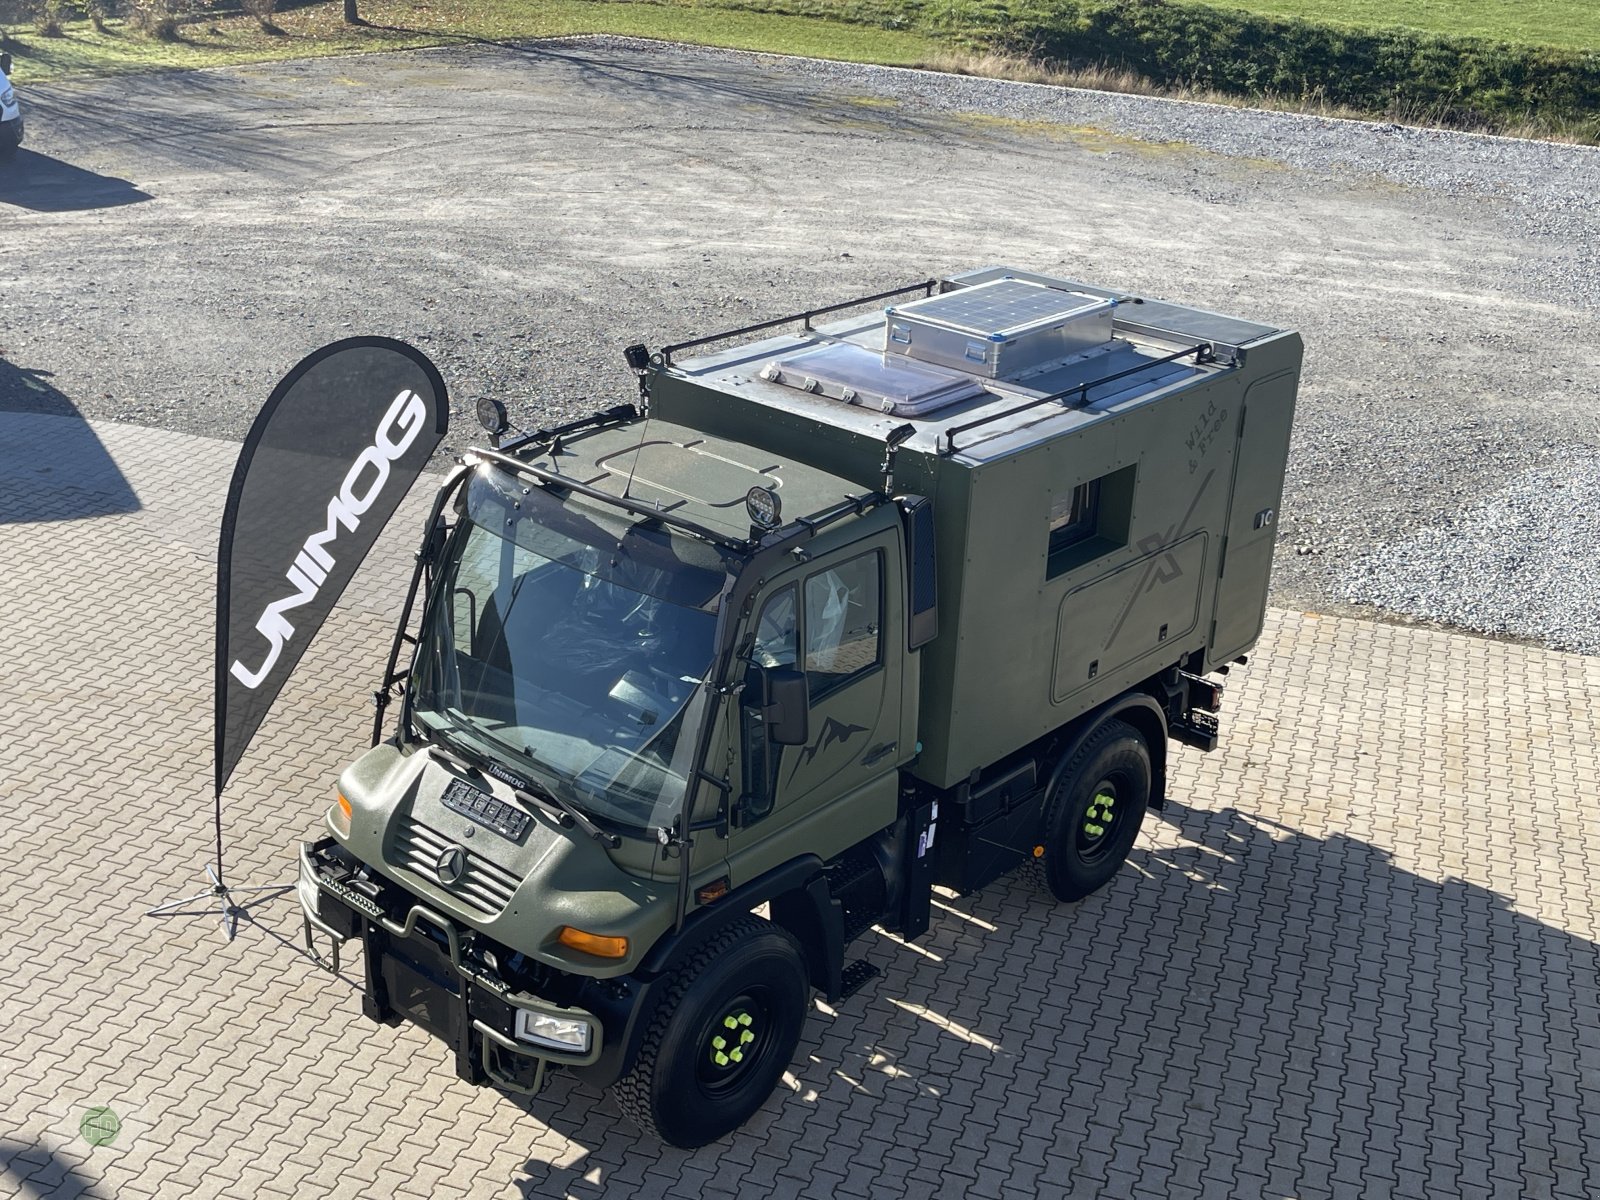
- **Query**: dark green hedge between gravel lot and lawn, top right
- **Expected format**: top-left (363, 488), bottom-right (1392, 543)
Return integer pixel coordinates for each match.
top-left (986, 0), bottom-right (1600, 126)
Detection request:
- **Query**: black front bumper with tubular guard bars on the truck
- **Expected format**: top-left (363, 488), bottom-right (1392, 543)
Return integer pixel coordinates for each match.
top-left (296, 837), bottom-right (633, 1094)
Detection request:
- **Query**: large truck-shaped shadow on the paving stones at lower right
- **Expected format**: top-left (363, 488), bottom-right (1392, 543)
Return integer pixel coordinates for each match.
top-left (492, 805), bottom-right (1600, 1198)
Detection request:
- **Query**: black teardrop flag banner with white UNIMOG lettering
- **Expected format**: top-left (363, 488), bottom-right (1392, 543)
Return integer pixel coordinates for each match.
top-left (216, 338), bottom-right (450, 800)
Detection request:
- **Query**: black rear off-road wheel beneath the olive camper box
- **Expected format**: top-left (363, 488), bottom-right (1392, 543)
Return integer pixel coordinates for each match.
top-left (1035, 720), bottom-right (1152, 902)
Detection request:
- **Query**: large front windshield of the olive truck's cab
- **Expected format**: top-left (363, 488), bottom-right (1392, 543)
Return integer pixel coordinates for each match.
top-left (413, 467), bottom-right (723, 829)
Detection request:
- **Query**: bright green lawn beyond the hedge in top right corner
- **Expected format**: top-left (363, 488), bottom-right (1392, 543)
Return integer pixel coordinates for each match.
top-left (1177, 0), bottom-right (1600, 51)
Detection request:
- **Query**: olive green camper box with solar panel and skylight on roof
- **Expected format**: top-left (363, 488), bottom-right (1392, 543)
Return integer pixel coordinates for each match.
top-left (651, 267), bottom-right (1301, 787)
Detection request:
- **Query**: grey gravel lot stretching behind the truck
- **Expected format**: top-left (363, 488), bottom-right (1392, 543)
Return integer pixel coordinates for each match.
top-left (0, 40), bottom-right (1600, 653)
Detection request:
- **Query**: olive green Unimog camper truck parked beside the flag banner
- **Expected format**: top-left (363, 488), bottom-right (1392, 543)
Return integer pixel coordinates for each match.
top-left (299, 269), bottom-right (1301, 1146)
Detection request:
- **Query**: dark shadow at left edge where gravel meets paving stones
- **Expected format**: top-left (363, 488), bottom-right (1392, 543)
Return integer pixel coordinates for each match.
top-left (0, 358), bottom-right (141, 525)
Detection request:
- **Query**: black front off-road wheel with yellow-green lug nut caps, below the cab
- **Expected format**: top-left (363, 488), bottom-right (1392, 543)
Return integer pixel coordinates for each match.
top-left (611, 915), bottom-right (811, 1149)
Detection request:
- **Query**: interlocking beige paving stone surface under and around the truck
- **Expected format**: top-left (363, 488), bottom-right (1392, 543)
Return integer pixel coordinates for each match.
top-left (0, 413), bottom-right (1600, 1200)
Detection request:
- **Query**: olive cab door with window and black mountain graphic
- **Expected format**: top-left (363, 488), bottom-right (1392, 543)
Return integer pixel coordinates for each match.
top-left (731, 528), bottom-right (910, 874)
